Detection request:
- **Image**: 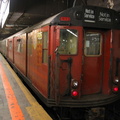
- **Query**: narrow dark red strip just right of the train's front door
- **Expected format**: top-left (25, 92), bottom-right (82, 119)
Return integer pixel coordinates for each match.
top-left (102, 30), bottom-right (113, 95)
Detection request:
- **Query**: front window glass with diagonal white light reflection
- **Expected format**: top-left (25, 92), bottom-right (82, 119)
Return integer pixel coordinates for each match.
top-left (58, 29), bottom-right (78, 55)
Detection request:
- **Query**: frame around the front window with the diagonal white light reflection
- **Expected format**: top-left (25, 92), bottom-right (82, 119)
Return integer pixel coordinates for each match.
top-left (58, 28), bottom-right (79, 55)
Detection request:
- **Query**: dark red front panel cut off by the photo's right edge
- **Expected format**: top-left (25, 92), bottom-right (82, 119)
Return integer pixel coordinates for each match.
top-left (111, 30), bottom-right (120, 87)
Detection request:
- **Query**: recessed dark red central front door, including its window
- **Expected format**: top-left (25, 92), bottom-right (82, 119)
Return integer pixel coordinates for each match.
top-left (82, 30), bottom-right (104, 95)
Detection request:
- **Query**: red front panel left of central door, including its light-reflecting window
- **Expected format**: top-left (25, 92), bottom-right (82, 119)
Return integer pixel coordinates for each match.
top-left (55, 26), bottom-right (83, 100)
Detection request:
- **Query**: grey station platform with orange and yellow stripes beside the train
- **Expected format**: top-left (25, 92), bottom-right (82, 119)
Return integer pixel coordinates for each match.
top-left (0, 54), bottom-right (52, 120)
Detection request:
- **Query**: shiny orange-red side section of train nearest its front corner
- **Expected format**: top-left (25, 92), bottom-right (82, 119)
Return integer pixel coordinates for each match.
top-left (27, 26), bottom-right (49, 98)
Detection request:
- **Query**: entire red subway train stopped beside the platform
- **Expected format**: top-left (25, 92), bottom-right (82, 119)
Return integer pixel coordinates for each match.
top-left (0, 6), bottom-right (120, 120)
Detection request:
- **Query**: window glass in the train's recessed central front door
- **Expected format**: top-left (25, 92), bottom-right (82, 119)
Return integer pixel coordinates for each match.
top-left (84, 32), bottom-right (102, 56)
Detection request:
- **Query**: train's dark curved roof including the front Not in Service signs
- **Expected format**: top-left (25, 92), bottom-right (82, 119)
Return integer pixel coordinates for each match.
top-left (2, 6), bottom-right (120, 37)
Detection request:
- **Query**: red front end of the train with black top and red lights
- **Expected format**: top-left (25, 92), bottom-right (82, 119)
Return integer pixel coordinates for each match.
top-left (47, 7), bottom-right (120, 119)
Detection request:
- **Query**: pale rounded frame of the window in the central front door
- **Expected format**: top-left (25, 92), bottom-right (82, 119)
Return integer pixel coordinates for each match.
top-left (84, 31), bottom-right (103, 57)
